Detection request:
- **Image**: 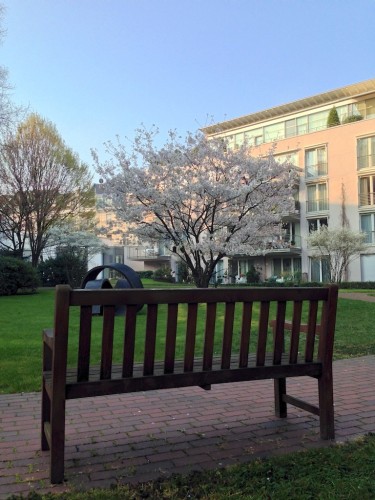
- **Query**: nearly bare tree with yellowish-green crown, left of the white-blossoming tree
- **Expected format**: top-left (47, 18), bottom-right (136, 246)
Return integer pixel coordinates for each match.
top-left (0, 114), bottom-right (94, 266)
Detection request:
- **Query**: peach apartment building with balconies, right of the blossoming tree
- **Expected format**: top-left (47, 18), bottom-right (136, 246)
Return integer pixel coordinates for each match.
top-left (203, 79), bottom-right (375, 281)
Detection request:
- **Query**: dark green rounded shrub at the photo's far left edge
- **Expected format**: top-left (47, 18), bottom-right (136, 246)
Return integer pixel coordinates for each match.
top-left (0, 257), bottom-right (40, 295)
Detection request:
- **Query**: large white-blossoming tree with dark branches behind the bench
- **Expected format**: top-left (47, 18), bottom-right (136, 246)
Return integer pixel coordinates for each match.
top-left (94, 129), bottom-right (297, 287)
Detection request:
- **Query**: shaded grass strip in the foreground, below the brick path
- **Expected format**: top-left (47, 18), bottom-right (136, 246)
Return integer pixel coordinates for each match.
top-left (9, 434), bottom-right (375, 500)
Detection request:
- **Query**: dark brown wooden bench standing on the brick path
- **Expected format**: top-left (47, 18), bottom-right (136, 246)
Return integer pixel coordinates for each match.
top-left (41, 285), bottom-right (338, 483)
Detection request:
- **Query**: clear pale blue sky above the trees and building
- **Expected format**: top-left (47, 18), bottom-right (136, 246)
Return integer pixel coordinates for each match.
top-left (0, 0), bottom-right (375, 174)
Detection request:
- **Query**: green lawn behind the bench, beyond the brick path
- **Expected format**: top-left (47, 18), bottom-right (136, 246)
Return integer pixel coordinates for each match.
top-left (0, 280), bottom-right (375, 393)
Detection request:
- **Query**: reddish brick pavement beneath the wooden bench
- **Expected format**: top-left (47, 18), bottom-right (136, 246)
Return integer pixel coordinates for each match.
top-left (0, 356), bottom-right (375, 499)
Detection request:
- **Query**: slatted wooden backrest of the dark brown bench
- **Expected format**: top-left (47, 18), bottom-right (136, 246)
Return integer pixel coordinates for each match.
top-left (53, 285), bottom-right (338, 381)
